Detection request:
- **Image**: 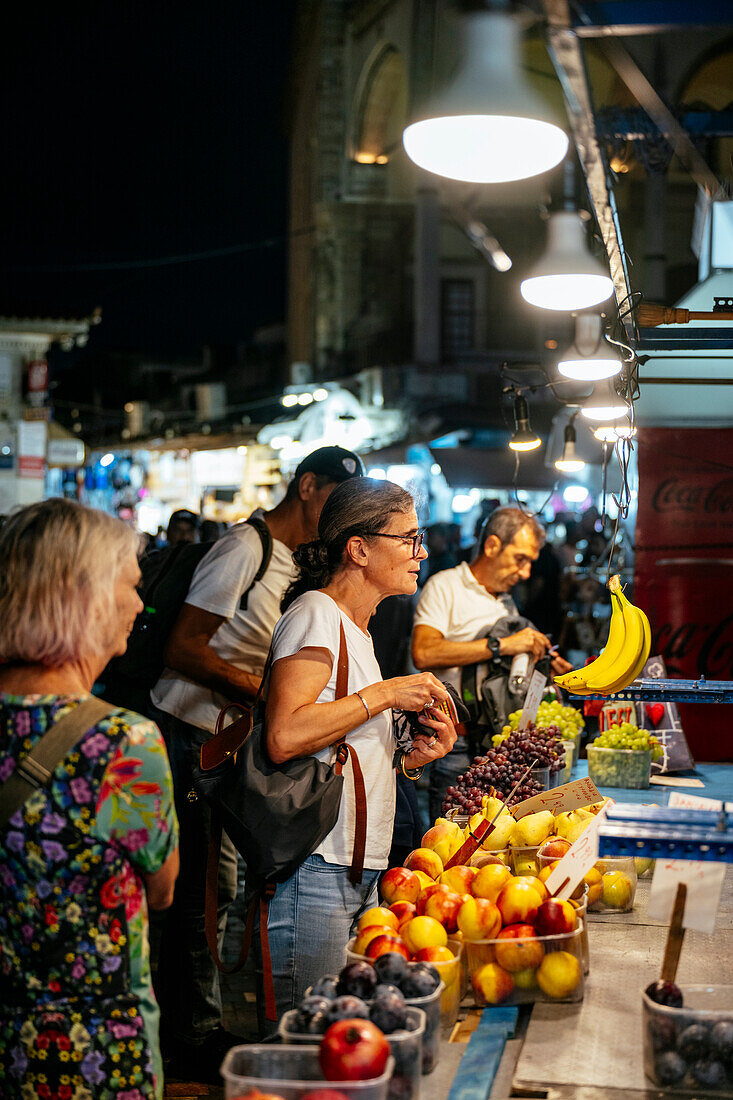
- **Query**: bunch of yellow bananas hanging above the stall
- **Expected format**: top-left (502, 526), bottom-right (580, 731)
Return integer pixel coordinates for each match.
top-left (555, 576), bottom-right (652, 695)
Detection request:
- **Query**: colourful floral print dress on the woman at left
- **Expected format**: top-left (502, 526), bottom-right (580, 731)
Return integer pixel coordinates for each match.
top-left (0, 693), bottom-right (178, 1100)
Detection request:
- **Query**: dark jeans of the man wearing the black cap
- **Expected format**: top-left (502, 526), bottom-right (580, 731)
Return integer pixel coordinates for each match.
top-left (154, 711), bottom-right (237, 1047)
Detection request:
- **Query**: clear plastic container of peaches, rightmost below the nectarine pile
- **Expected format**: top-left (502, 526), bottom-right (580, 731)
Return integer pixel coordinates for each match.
top-left (464, 922), bottom-right (584, 1008)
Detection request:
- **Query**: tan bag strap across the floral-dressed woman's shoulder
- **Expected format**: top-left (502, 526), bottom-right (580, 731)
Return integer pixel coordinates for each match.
top-left (0, 696), bottom-right (117, 828)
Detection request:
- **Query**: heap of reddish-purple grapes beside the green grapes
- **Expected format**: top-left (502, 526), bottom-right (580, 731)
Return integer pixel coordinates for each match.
top-left (442, 724), bottom-right (565, 817)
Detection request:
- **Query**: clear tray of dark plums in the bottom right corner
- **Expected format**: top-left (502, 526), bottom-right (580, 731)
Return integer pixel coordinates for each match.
top-left (642, 981), bottom-right (733, 1096)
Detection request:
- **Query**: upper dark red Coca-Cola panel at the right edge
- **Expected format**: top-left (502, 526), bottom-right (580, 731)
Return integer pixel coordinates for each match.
top-left (636, 428), bottom-right (733, 553)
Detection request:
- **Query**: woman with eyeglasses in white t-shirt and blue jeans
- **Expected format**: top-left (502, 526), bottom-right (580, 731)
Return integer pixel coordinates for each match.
top-left (254, 477), bottom-right (456, 1023)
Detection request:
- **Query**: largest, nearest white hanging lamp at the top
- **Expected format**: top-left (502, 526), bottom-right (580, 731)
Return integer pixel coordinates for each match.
top-left (403, 11), bottom-right (568, 184)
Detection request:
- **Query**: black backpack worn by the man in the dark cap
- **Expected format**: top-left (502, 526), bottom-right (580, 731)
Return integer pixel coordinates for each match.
top-left (99, 517), bottom-right (272, 714)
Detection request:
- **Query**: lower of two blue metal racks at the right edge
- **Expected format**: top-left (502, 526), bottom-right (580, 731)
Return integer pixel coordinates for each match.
top-left (599, 802), bottom-right (733, 864)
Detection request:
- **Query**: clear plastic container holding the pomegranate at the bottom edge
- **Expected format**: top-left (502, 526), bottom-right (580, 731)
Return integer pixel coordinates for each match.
top-left (221, 1043), bottom-right (394, 1100)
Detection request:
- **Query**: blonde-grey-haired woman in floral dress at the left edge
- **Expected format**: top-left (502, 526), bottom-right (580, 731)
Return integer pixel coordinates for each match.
top-left (0, 499), bottom-right (178, 1100)
